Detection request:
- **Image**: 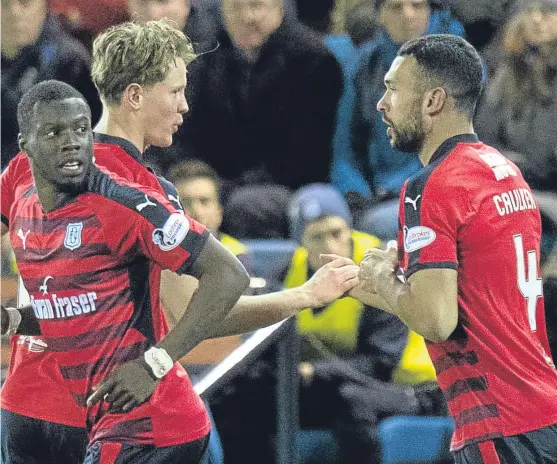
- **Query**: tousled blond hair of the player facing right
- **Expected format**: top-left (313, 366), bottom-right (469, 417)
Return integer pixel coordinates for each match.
top-left (91, 20), bottom-right (196, 104)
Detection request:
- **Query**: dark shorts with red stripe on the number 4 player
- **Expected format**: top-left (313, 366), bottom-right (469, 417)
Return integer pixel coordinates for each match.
top-left (454, 424), bottom-right (557, 464)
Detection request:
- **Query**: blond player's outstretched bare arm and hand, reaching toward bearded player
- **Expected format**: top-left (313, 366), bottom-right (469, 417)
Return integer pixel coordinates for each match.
top-left (210, 257), bottom-right (360, 337)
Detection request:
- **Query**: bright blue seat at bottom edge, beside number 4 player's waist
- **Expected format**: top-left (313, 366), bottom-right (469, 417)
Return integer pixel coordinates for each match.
top-left (378, 416), bottom-right (454, 464)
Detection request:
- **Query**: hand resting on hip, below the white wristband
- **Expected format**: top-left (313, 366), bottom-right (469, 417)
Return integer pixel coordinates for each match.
top-left (87, 358), bottom-right (160, 412)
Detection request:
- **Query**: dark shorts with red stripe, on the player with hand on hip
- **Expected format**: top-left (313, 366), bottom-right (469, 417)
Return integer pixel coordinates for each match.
top-left (83, 435), bottom-right (209, 464)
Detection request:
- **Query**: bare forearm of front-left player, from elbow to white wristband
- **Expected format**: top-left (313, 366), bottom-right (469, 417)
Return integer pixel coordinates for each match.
top-left (157, 267), bottom-right (249, 361)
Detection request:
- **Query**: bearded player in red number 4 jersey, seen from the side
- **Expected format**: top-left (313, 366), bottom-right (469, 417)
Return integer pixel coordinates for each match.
top-left (338, 35), bottom-right (557, 464)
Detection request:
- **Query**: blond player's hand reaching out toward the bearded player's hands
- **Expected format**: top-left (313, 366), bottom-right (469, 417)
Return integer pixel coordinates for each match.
top-left (300, 255), bottom-right (360, 308)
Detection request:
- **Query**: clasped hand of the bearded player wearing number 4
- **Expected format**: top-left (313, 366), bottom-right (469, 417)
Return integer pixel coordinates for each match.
top-left (359, 241), bottom-right (398, 293)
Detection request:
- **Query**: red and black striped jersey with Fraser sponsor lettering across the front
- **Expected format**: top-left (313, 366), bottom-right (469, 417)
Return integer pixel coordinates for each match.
top-left (9, 169), bottom-right (209, 446)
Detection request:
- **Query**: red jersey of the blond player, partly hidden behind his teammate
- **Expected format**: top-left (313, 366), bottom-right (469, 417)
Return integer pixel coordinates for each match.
top-left (0, 134), bottom-right (210, 439)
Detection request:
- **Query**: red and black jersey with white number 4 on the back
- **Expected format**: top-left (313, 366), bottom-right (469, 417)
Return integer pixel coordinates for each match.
top-left (398, 134), bottom-right (557, 450)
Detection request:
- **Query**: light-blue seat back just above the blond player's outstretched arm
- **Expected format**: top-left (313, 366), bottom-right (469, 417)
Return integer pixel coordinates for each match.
top-left (242, 239), bottom-right (298, 291)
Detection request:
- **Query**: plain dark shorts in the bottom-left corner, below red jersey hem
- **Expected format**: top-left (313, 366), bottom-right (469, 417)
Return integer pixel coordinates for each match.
top-left (0, 409), bottom-right (88, 464)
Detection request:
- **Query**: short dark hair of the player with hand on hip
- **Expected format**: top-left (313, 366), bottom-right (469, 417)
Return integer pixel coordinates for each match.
top-left (17, 80), bottom-right (91, 134)
